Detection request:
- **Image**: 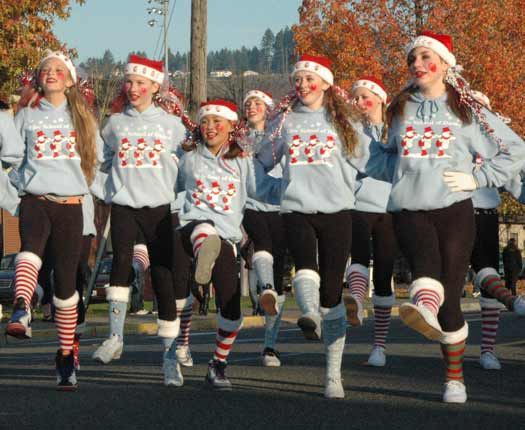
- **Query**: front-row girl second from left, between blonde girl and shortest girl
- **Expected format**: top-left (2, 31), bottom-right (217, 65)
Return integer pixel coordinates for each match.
top-left (93, 55), bottom-right (187, 385)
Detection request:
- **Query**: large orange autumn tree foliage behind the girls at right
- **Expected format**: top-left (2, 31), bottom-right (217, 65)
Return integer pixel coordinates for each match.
top-left (293, 0), bottom-right (525, 214)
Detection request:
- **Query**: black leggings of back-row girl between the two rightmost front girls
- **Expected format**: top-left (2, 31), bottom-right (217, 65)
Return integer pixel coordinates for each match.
top-left (350, 210), bottom-right (396, 297)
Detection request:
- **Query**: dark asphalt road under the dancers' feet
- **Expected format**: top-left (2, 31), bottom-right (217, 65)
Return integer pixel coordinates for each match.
top-left (0, 313), bottom-right (525, 430)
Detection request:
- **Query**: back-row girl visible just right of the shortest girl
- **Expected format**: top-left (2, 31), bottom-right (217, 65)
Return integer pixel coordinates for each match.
top-left (243, 90), bottom-right (286, 367)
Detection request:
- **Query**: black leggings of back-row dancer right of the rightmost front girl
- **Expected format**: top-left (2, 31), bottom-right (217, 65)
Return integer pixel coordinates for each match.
top-left (470, 208), bottom-right (499, 298)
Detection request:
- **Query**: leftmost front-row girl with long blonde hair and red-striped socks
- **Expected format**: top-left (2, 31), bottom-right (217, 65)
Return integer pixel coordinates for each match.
top-left (6, 51), bottom-right (102, 390)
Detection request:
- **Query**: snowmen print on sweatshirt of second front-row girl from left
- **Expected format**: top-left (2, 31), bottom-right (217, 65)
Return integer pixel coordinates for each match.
top-left (115, 124), bottom-right (173, 169)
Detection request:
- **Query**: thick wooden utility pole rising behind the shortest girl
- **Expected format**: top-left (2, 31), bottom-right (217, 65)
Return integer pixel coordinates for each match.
top-left (188, 0), bottom-right (208, 115)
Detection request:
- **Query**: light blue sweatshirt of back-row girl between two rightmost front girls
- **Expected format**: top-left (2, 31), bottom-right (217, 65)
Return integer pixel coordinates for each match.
top-left (355, 124), bottom-right (392, 213)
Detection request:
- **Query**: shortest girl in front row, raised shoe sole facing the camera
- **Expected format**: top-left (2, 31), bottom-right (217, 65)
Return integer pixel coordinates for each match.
top-left (178, 100), bottom-right (280, 390)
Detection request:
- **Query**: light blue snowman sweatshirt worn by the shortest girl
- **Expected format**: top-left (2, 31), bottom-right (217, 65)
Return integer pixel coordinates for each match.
top-left (178, 144), bottom-right (281, 242)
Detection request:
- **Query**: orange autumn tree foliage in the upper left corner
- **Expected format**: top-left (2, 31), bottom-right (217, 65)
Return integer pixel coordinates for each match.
top-left (0, 0), bottom-right (85, 95)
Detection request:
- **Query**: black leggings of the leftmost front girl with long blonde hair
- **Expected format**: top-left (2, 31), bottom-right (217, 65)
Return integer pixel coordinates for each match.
top-left (20, 194), bottom-right (83, 300)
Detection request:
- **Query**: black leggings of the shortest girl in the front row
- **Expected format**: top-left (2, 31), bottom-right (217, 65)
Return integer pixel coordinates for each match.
top-left (179, 221), bottom-right (241, 321)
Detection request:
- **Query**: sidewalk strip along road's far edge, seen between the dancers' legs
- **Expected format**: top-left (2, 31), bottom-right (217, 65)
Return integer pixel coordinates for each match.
top-left (23, 297), bottom-right (480, 339)
